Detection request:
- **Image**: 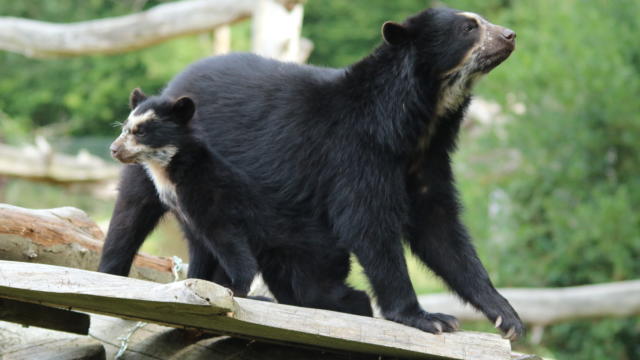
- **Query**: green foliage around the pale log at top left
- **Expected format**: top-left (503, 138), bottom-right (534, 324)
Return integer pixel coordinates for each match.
top-left (0, 0), bottom-right (211, 138)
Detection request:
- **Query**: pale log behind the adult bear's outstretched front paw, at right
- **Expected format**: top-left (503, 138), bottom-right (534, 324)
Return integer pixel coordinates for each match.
top-left (419, 280), bottom-right (640, 326)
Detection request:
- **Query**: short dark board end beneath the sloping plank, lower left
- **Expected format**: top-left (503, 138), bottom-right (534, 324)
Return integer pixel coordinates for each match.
top-left (0, 299), bottom-right (89, 335)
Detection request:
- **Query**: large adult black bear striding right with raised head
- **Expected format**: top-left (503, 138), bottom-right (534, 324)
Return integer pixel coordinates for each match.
top-left (100, 8), bottom-right (523, 338)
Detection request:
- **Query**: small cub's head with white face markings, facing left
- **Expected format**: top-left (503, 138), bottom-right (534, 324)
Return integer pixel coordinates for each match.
top-left (110, 89), bottom-right (196, 166)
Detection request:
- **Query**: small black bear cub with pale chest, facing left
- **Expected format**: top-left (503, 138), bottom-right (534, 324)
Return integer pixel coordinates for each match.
top-left (111, 89), bottom-right (372, 316)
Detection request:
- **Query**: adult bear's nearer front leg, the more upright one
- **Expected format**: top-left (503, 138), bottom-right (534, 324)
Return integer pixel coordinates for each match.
top-left (330, 160), bottom-right (458, 334)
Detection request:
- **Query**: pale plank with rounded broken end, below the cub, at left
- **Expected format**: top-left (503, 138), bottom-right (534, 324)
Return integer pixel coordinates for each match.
top-left (0, 261), bottom-right (233, 323)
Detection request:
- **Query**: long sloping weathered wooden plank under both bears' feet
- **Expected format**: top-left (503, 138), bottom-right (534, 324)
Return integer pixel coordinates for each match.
top-left (0, 261), bottom-right (511, 360)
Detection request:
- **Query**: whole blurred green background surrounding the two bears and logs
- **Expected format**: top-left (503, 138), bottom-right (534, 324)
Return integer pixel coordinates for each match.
top-left (0, 0), bottom-right (640, 360)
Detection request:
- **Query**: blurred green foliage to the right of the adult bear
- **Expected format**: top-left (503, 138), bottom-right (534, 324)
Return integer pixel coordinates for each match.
top-left (460, 1), bottom-right (640, 359)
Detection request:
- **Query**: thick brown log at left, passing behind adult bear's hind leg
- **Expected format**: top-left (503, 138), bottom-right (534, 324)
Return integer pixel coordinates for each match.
top-left (0, 203), bottom-right (185, 283)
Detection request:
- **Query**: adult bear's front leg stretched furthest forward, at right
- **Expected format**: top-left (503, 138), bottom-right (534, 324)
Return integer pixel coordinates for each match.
top-left (408, 162), bottom-right (524, 340)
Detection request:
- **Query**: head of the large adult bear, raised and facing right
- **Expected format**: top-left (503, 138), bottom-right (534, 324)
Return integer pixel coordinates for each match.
top-left (382, 8), bottom-right (516, 112)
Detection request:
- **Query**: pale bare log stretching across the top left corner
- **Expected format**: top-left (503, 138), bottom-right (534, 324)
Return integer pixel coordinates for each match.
top-left (0, 0), bottom-right (304, 57)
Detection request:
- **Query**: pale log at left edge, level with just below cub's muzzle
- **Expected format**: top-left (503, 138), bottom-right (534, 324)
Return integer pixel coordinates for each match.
top-left (0, 141), bottom-right (121, 184)
